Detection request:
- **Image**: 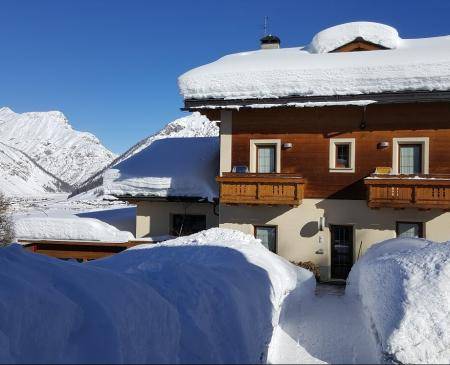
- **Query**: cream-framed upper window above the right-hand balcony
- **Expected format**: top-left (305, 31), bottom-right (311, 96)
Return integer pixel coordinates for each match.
top-left (392, 137), bottom-right (430, 175)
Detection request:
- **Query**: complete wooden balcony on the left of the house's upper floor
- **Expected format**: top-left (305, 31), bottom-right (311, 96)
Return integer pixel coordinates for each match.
top-left (217, 173), bottom-right (305, 206)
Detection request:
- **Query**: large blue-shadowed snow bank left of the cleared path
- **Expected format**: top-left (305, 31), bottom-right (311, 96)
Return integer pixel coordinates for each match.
top-left (0, 229), bottom-right (312, 363)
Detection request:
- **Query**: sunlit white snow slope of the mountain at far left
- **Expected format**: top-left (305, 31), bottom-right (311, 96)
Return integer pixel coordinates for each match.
top-left (0, 107), bottom-right (116, 193)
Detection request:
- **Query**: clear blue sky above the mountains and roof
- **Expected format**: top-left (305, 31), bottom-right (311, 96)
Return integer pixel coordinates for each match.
top-left (0, 0), bottom-right (450, 153)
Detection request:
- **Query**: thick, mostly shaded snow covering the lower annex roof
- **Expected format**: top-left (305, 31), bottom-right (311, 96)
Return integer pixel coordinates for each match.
top-left (103, 137), bottom-right (219, 201)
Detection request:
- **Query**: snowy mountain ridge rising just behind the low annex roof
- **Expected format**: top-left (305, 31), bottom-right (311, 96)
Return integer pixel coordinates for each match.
top-left (72, 112), bottom-right (219, 196)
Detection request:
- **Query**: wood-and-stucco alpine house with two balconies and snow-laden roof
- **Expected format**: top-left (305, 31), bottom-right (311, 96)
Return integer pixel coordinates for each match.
top-left (179, 22), bottom-right (450, 279)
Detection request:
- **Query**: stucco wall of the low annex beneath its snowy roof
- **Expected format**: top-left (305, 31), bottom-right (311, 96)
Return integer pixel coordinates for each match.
top-left (134, 201), bottom-right (219, 238)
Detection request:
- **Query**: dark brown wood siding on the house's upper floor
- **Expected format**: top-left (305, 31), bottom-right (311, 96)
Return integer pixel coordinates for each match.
top-left (232, 103), bottom-right (450, 199)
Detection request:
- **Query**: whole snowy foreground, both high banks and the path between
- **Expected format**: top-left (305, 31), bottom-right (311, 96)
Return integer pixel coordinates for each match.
top-left (0, 228), bottom-right (450, 363)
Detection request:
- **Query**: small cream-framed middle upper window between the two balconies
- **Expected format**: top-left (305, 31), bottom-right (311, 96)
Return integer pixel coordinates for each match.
top-left (330, 138), bottom-right (355, 173)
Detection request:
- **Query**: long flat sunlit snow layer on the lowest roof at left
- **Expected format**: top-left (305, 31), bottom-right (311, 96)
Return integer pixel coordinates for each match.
top-left (14, 217), bottom-right (134, 242)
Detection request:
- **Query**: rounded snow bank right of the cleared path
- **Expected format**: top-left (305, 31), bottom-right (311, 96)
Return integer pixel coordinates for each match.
top-left (346, 239), bottom-right (450, 363)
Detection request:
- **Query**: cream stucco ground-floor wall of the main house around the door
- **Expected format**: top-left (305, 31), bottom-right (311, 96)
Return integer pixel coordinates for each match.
top-left (219, 199), bottom-right (450, 278)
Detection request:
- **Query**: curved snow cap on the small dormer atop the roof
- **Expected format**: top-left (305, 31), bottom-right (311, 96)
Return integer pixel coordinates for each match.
top-left (310, 22), bottom-right (400, 53)
